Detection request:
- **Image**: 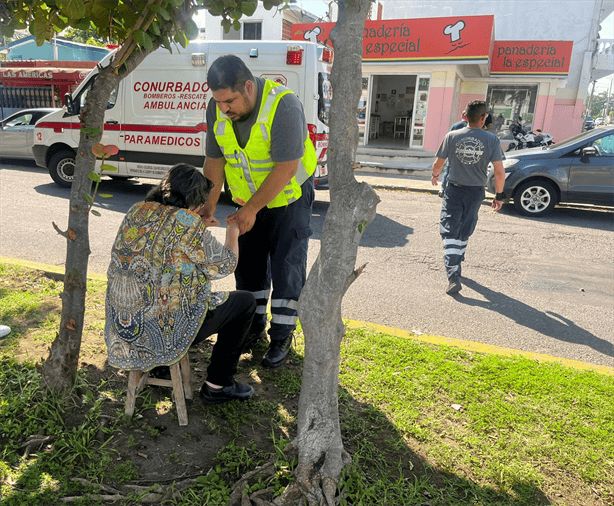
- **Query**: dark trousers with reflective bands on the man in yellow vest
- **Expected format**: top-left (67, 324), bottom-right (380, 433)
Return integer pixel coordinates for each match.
top-left (235, 177), bottom-right (314, 341)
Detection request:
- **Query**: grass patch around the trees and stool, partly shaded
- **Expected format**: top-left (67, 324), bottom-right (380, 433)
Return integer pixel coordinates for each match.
top-left (0, 264), bottom-right (614, 506)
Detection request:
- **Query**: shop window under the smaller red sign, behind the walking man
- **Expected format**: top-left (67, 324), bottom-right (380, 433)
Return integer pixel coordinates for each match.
top-left (486, 84), bottom-right (537, 140)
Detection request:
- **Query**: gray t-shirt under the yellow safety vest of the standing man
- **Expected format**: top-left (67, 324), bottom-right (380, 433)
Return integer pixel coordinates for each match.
top-left (205, 77), bottom-right (308, 162)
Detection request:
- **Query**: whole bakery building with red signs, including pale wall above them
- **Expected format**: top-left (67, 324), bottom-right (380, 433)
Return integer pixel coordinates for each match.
top-left (292, 0), bottom-right (614, 151)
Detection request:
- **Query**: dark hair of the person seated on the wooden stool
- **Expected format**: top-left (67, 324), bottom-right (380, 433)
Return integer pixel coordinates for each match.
top-left (145, 163), bottom-right (213, 209)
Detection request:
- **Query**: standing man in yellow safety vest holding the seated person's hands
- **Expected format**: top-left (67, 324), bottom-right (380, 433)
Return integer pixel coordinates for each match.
top-left (203, 55), bottom-right (317, 367)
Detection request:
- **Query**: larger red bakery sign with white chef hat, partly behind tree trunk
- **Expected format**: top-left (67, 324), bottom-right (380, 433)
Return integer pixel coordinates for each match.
top-left (292, 16), bottom-right (494, 62)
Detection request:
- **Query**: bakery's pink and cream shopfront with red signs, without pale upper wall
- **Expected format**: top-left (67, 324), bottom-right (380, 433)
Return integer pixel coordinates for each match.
top-left (292, 15), bottom-right (581, 151)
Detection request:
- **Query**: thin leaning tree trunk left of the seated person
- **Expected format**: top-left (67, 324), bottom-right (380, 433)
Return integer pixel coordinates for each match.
top-left (41, 51), bottom-right (151, 392)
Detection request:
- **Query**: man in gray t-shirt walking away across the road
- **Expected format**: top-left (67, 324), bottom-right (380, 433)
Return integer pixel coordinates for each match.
top-left (431, 100), bottom-right (505, 295)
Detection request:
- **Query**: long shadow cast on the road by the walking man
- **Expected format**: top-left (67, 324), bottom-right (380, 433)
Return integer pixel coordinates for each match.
top-left (455, 278), bottom-right (614, 357)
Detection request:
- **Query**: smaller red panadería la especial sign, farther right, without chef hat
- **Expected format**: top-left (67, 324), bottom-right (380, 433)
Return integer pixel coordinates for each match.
top-left (490, 40), bottom-right (573, 77)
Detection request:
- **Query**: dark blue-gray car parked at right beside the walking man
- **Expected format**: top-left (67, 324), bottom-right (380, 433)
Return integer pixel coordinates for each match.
top-left (487, 126), bottom-right (614, 217)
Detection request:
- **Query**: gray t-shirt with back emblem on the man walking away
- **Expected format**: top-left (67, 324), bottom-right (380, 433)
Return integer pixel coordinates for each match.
top-left (435, 127), bottom-right (503, 186)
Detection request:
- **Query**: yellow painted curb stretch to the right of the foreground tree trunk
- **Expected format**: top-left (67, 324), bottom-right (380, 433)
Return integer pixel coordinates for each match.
top-left (344, 320), bottom-right (614, 376)
